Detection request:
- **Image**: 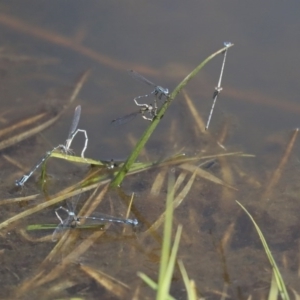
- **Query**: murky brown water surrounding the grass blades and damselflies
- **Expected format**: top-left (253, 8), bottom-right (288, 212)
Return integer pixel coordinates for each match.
top-left (0, 0), bottom-right (300, 299)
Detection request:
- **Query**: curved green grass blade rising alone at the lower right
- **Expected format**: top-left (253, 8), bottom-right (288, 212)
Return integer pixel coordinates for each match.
top-left (236, 200), bottom-right (290, 300)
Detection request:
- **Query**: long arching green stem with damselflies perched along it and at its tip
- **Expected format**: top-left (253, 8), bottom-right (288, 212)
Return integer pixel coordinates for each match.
top-left (111, 44), bottom-right (233, 187)
